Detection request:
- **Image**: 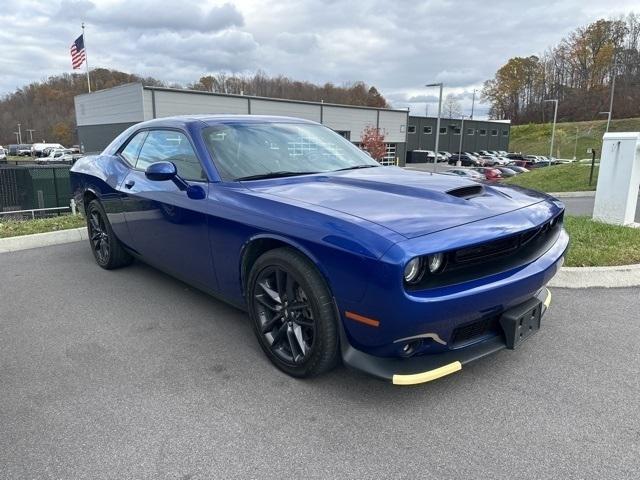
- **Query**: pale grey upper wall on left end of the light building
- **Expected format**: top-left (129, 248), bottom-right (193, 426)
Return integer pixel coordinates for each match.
top-left (74, 83), bottom-right (144, 126)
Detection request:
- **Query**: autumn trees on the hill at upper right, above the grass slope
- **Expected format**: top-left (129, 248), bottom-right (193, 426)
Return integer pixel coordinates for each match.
top-left (482, 13), bottom-right (640, 124)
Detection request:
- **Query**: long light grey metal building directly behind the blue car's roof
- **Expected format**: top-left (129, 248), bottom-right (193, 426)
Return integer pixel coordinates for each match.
top-left (75, 83), bottom-right (409, 165)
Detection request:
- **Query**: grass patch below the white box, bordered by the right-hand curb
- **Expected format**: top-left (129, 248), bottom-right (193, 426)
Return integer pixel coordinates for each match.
top-left (564, 216), bottom-right (640, 267)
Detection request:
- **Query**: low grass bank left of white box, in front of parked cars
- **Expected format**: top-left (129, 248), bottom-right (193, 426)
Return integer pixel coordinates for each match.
top-left (503, 163), bottom-right (598, 192)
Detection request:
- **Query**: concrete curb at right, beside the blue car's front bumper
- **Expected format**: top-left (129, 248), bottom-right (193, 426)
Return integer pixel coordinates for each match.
top-left (549, 264), bottom-right (640, 288)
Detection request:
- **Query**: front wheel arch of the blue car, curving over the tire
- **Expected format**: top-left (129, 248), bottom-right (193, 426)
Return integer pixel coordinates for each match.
top-left (239, 234), bottom-right (333, 296)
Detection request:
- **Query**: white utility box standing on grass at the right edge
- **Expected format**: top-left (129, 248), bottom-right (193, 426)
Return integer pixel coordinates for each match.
top-left (593, 132), bottom-right (640, 225)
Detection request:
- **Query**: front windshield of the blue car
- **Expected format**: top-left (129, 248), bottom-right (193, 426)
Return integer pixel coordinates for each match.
top-left (203, 123), bottom-right (380, 180)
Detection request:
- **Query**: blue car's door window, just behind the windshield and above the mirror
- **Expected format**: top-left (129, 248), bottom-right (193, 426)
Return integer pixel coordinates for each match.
top-left (136, 130), bottom-right (207, 180)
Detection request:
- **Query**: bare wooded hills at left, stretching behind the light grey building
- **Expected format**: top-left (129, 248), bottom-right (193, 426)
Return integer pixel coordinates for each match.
top-left (0, 68), bottom-right (388, 146)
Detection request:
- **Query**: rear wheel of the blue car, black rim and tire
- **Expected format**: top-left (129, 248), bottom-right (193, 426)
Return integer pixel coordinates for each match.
top-left (87, 200), bottom-right (133, 270)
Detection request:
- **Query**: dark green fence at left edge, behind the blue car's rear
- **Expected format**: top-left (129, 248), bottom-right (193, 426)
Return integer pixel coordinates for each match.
top-left (0, 165), bottom-right (71, 212)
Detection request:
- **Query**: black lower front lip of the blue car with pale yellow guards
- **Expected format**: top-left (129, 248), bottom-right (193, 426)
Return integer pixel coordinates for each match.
top-left (341, 288), bottom-right (551, 385)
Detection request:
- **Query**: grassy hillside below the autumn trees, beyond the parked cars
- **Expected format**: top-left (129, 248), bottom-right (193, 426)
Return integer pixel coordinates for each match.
top-left (509, 118), bottom-right (640, 159)
